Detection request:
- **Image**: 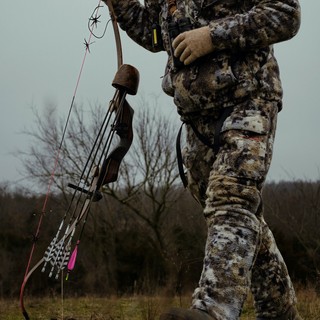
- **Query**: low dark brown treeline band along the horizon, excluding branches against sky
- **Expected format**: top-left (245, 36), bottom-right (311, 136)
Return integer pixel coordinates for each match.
top-left (0, 181), bottom-right (320, 298)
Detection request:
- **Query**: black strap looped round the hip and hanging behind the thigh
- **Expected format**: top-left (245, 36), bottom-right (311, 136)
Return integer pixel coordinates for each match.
top-left (176, 107), bottom-right (233, 188)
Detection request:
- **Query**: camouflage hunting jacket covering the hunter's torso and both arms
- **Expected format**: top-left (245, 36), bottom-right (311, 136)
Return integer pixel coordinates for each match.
top-left (113, 0), bottom-right (300, 114)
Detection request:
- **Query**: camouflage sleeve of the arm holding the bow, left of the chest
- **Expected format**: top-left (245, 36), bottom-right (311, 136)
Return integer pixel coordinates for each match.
top-left (112, 0), bottom-right (164, 52)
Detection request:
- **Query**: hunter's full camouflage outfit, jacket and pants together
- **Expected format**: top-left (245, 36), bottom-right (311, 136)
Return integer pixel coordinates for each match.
top-left (109, 0), bottom-right (300, 320)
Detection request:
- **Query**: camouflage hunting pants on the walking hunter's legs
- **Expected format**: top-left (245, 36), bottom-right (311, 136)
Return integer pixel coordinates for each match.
top-left (184, 99), bottom-right (295, 320)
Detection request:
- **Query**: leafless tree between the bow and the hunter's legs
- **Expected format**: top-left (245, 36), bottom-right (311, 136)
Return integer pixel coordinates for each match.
top-left (105, 96), bottom-right (181, 251)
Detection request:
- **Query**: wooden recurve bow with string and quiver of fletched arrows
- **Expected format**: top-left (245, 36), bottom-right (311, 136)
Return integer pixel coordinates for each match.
top-left (20, 0), bottom-right (139, 320)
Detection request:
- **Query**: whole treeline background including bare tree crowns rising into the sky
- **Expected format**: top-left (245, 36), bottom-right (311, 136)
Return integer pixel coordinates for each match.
top-left (0, 101), bottom-right (320, 297)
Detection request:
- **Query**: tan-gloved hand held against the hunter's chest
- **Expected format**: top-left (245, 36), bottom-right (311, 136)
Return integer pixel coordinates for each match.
top-left (172, 26), bottom-right (214, 65)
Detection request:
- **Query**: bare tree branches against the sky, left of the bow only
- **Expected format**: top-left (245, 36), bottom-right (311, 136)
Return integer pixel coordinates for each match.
top-left (17, 105), bottom-right (104, 194)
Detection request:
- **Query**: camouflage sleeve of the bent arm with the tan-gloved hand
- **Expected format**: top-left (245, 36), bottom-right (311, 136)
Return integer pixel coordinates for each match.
top-left (209, 0), bottom-right (300, 51)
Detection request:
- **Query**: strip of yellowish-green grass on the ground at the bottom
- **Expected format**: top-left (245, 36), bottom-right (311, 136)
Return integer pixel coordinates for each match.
top-left (0, 289), bottom-right (320, 320)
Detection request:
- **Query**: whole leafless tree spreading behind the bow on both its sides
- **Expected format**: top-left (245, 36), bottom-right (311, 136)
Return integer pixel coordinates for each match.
top-left (19, 99), bottom-right (188, 292)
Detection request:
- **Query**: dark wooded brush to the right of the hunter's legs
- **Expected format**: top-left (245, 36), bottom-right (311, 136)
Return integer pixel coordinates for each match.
top-left (264, 181), bottom-right (320, 279)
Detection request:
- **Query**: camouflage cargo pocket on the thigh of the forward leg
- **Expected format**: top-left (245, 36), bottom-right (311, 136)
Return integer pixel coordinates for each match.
top-left (218, 108), bottom-right (277, 182)
